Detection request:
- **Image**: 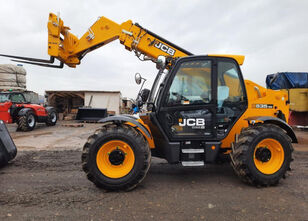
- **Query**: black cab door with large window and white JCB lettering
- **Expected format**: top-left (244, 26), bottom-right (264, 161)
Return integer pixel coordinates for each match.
top-left (157, 56), bottom-right (217, 141)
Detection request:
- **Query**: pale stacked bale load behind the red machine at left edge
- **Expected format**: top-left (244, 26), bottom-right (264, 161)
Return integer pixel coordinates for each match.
top-left (0, 64), bottom-right (27, 90)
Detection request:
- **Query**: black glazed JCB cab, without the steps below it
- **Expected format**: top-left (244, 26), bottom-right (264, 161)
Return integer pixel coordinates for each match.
top-left (155, 56), bottom-right (247, 140)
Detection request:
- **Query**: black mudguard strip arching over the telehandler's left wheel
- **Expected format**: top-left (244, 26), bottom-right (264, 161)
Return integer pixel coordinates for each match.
top-left (98, 115), bottom-right (152, 139)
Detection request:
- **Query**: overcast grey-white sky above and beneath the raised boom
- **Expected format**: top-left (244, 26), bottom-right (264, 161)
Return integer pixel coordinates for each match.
top-left (0, 0), bottom-right (308, 98)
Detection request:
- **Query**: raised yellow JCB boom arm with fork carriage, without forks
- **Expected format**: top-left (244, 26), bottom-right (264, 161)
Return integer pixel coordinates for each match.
top-left (47, 13), bottom-right (192, 67)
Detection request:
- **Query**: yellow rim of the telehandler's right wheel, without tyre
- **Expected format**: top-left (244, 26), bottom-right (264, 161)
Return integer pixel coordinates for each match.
top-left (253, 138), bottom-right (284, 175)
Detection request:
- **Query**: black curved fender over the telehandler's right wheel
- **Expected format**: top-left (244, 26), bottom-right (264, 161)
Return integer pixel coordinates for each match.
top-left (245, 117), bottom-right (298, 143)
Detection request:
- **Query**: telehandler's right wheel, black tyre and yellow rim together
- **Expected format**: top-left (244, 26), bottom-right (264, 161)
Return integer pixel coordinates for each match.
top-left (230, 124), bottom-right (293, 186)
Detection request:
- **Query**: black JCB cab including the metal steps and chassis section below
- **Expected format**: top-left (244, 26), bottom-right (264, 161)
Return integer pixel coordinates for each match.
top-left (140, 56), bottom-right (248, 166)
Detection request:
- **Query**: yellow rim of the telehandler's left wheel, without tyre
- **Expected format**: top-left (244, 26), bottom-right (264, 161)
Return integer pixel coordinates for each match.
top-left (96, 140), bottom-right (135, 178)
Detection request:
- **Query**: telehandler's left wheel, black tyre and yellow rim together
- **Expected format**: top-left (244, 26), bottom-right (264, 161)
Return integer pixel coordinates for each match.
top-left (81, 124), bottom-right (151, 190)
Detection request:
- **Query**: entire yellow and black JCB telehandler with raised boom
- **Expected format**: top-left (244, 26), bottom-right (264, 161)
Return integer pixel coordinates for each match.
top-left (1, 13), bottom-right (297, 190)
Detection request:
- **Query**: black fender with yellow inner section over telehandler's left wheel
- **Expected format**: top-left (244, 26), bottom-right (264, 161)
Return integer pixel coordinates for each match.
top-left (98, 115), bottom-right (154, 148)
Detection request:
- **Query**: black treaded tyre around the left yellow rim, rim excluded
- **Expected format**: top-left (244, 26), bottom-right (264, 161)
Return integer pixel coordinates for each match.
top-left (81, 124), bottom-right (151, 190)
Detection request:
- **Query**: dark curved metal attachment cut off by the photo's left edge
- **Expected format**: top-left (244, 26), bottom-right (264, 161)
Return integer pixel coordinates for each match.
top-left (0, 120), bottom-right (17, 166)
